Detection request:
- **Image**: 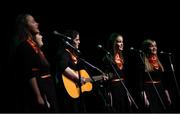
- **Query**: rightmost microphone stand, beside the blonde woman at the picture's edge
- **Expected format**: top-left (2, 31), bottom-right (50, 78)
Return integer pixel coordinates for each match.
top-left (168, 54), bottom-right (180, 96)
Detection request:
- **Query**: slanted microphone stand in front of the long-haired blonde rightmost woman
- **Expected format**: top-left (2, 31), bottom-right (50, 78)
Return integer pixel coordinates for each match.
top-left (139, 53), bottom-right (166, 110)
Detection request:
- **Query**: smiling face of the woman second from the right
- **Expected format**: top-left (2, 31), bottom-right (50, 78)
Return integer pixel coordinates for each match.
top-left (115, 36), bottom-right (124, 51)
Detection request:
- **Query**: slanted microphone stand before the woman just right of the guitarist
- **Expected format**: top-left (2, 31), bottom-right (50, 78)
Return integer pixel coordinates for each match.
top-left (106, 53), bottom-right (139, 109)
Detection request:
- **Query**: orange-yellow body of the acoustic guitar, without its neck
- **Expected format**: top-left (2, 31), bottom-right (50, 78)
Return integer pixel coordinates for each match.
top-left (62, 70), bottom-right (92, 98)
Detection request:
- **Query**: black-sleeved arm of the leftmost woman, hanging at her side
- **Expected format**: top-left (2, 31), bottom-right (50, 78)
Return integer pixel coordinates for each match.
top-left (17, 42), bottom-right (44, 104)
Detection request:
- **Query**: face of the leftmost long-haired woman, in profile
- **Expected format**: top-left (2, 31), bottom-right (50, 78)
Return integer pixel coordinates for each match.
top-left (26, 15), bottom-right (39, 34)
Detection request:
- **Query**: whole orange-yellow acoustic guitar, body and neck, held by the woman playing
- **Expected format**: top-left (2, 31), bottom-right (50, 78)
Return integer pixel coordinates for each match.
top-left (62, 70), bottom-right (107, 98)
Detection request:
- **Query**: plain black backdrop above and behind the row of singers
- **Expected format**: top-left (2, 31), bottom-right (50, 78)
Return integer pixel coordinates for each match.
top-left (0, 1), bottom-right (180, 112)
